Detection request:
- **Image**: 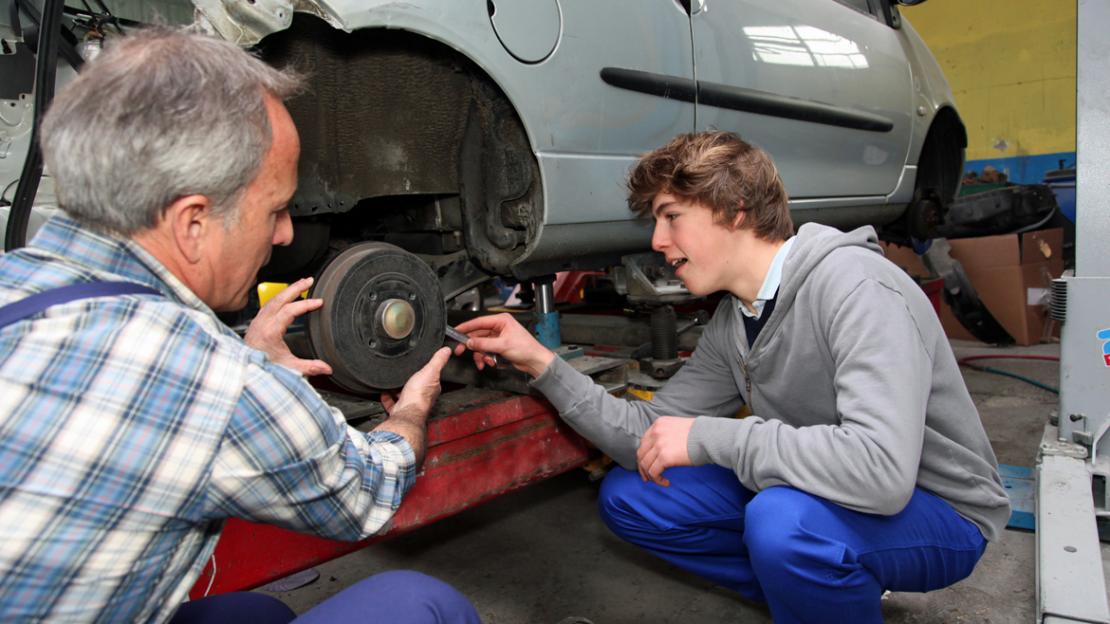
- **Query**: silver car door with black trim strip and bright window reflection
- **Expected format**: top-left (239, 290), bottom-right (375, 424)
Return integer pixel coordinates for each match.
top-left (690, 0), bottom-right (914, 200)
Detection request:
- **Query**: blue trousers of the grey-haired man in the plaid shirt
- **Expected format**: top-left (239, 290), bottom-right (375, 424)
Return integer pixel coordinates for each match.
top-left (170, 571), bottom-right (482, 624)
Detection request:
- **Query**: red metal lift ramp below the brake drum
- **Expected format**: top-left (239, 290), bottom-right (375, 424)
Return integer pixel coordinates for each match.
top-left (190, 388), bottom-right (589, 598)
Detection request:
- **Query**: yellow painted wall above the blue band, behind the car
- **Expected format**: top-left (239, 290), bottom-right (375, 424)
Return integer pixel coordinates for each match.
top-left (900, 0), bottom-right (1076, 160)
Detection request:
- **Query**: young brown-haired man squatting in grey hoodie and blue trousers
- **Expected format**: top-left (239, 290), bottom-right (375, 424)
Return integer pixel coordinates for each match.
top-left (458, 132), bottom-right (1009, 623)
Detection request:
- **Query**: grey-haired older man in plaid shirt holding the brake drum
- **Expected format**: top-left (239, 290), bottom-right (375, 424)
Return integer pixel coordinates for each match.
top-left (0, 30), bottom-right (477, 622)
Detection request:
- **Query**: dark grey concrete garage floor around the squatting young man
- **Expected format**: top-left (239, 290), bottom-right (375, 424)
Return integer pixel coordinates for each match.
top-left (259, 342), bottom-right (1110, 624)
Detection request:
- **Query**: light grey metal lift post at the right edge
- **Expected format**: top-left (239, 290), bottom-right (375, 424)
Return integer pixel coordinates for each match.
top-left (1037, 0), bottom-right (1110, 624)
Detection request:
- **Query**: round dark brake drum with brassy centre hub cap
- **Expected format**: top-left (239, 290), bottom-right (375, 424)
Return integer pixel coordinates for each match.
top-left (306, 242), bottom-right (446, 393)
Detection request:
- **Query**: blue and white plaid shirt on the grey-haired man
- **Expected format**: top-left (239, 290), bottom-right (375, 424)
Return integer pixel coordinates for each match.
top-left (0, 217), bottom-right (415, 622)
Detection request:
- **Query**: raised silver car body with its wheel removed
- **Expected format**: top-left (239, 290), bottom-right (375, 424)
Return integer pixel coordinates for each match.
top-left (0, 0), bottom-right (966, 284)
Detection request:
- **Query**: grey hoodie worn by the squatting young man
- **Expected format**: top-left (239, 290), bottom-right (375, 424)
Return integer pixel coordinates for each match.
top-left (533, 224), bottom-right (1010, 540)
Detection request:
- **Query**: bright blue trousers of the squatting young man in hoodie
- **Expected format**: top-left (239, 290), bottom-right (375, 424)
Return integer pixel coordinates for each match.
top-left (598, 465), bottom-right (987, 624)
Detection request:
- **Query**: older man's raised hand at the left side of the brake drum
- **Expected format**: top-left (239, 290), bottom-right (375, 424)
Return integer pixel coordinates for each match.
top-left (243, 278), bottom-right (332, 376)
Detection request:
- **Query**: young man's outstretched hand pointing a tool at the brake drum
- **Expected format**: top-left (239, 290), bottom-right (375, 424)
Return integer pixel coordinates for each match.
top-left (455, 313), bottom-right (555, 378)
